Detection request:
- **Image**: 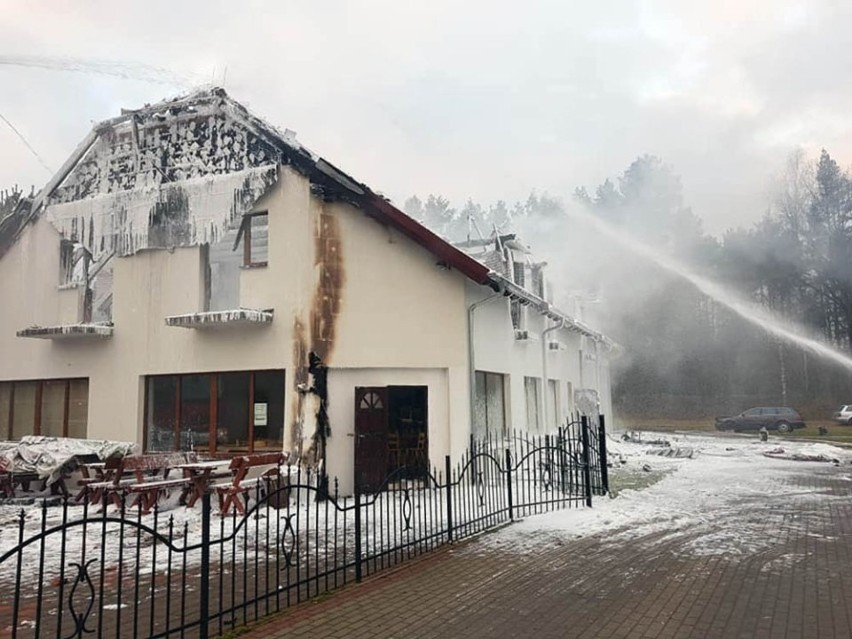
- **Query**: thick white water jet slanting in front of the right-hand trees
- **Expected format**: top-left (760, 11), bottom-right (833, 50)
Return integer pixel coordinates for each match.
top-left (567, 207), bottom-right (852, 371)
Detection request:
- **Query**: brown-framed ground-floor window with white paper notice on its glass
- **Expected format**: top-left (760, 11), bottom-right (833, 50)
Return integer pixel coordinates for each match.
top-left (145, 370), bottom-right (284, 453)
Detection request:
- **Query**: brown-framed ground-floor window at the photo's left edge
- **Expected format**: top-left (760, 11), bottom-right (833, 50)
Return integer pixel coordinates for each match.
top-left (0, 379), bottom-right (89, 440)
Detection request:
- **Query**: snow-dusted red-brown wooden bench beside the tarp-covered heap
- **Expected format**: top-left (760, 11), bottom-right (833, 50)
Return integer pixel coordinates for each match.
top-left (88, 452), bottom-right (197, 514)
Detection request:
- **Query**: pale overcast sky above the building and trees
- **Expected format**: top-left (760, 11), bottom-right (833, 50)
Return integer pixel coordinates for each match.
top-left (0, 0), bottom-right (852, 234)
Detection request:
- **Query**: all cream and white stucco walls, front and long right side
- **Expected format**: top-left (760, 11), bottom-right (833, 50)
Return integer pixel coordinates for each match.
top-left (0, 162), bottom-right (610, 486)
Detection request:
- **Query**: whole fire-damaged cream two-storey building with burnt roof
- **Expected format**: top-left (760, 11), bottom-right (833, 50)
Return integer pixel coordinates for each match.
top-left (0, 89), bottom-right (610, 488)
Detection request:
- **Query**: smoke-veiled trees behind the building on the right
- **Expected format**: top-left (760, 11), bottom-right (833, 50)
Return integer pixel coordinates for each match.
top-left (404, 151), bottom-right (852, 419)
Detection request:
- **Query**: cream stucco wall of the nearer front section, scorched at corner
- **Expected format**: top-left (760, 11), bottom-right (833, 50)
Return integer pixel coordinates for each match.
top-left (0, 167), bottom-right (468, 480)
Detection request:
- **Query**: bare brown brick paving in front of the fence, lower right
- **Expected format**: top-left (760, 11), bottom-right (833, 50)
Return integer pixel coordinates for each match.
top-left (244, 462), bottom-right (852, 639)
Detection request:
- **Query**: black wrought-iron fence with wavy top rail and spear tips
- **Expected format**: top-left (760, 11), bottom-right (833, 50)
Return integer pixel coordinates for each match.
top-left (0, 417), bottom-right (608, 639)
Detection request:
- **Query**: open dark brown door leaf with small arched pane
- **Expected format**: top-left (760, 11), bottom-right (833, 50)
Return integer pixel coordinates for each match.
top-left (355, 387), bottom-right (388, 493)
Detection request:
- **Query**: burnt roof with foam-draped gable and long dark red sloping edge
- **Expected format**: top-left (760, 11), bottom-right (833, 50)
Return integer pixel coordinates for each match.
top-left (0, 88), bottom-right (607, 348)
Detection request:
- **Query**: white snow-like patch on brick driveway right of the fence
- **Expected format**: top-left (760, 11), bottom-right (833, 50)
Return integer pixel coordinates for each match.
top-left (471, 433), bottom-right (852, 561)
